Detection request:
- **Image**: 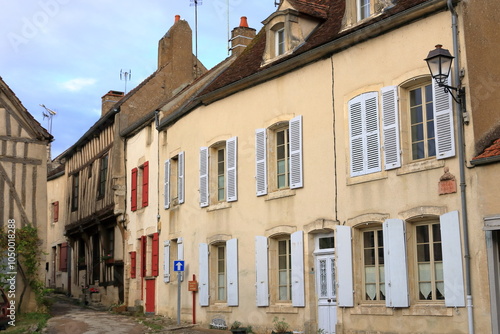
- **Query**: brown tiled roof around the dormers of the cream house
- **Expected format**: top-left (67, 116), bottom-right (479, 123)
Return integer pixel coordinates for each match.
top-left (202, 0), bottom-right (434, 94)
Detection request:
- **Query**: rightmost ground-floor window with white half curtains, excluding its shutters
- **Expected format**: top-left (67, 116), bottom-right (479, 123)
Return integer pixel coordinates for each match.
top-left (416, 223), bottom-right (444, 301)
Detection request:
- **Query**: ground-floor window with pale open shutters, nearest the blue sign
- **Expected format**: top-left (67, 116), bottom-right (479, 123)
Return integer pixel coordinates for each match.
top-left (199, 239), bottom-right (239, 306)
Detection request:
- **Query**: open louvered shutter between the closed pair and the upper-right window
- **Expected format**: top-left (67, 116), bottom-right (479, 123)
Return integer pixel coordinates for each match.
top-left (382, 86), bottom-right (401, 170)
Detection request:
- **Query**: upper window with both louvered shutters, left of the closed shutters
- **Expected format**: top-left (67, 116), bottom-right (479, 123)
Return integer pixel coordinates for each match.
top-left (255, 116), bottom-right (303, 196)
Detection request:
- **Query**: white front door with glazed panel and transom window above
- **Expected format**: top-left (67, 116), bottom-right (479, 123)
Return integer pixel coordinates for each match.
top-left (315, 235), bottom-right (337, 334)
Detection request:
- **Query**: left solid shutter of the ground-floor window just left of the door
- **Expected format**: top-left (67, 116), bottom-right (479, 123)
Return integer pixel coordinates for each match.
top-left (255, 236), bottom-right (269, 306)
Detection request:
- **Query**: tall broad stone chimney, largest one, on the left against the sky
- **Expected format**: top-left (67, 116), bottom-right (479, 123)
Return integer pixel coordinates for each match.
top-left (158, 15), bottom-right (193, 82)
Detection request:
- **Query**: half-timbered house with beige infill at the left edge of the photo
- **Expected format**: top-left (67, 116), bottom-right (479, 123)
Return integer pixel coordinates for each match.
top-left (0, 78), bottom-right (52, 307)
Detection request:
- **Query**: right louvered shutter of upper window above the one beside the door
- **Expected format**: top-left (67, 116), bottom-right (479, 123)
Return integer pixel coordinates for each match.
top-left (289, 116), bottom-right (304, 189)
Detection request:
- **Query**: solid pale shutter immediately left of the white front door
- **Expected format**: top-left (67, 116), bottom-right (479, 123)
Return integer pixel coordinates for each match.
top-left (290, 231), bottom-right (306, 307)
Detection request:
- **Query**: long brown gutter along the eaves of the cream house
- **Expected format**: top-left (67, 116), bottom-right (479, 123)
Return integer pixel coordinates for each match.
top-left (199, 0), bottom-right (450, 105)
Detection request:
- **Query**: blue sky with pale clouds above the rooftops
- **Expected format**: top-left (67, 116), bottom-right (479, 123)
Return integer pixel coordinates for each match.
top-left (0, 0), bottom-right (276, 158)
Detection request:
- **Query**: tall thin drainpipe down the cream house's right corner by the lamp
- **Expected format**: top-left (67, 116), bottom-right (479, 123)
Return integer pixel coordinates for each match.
top-left (448, 0), bottom-right (474, 334)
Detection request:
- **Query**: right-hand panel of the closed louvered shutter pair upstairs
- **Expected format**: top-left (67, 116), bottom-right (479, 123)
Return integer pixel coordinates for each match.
top-left (364, 92), bottom-right (382, 174)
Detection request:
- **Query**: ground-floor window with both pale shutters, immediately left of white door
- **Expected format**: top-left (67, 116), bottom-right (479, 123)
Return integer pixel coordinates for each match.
top-left (255, 231), bottom-right (305, 307)
